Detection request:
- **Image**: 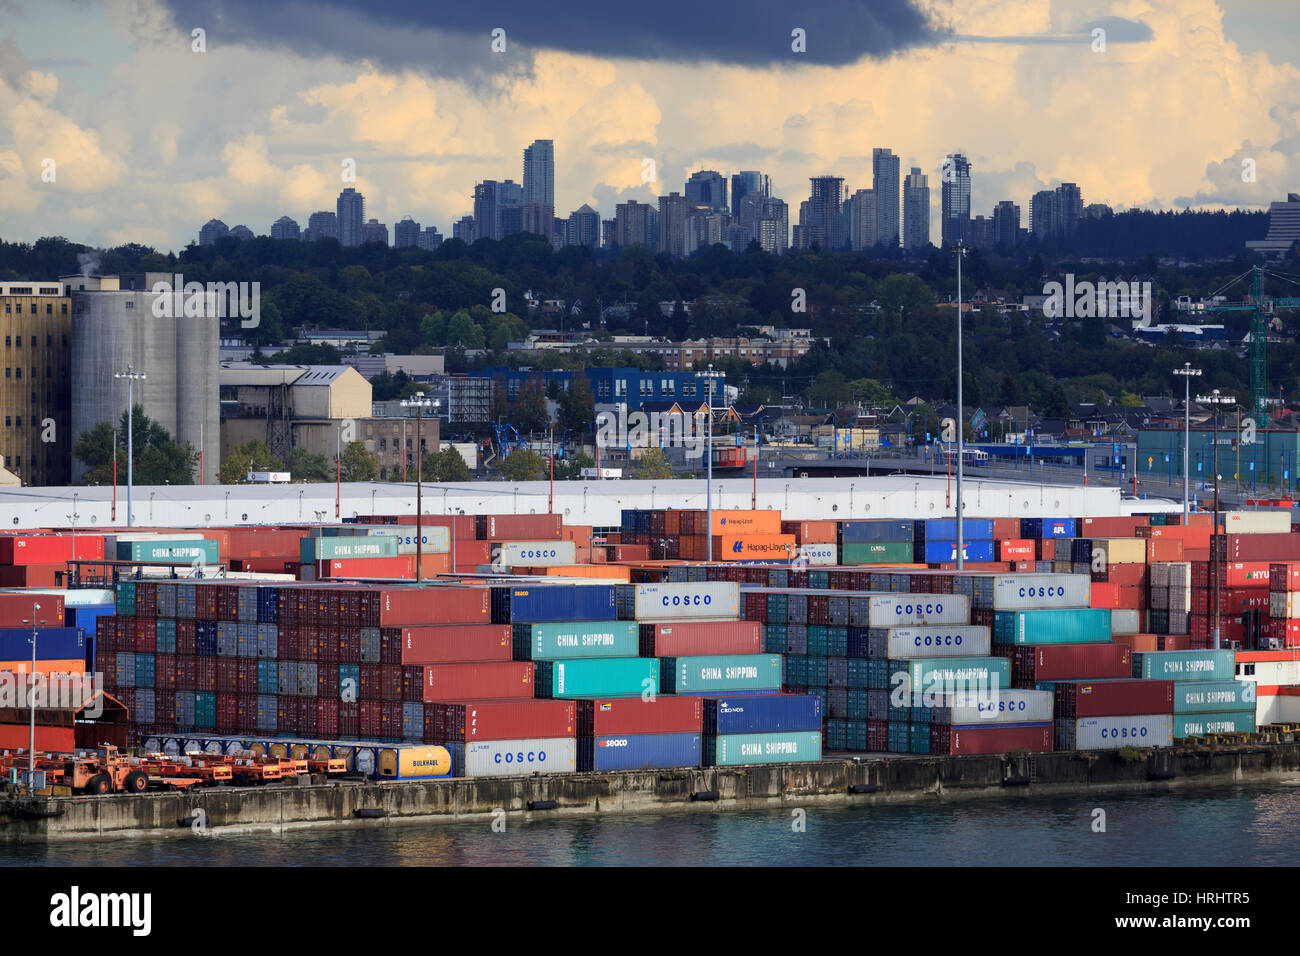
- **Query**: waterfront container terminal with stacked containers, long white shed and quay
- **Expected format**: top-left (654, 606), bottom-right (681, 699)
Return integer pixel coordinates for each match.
top-left (0, 477), bottom-right (1300, 839)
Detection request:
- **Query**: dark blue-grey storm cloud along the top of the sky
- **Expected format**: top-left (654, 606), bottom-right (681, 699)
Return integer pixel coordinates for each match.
top-left (164, 0), bottom-right (940, 75)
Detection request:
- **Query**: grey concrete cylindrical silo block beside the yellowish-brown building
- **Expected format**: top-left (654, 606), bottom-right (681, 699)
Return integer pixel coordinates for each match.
top-left (60, 272), bottom-right (222, 483)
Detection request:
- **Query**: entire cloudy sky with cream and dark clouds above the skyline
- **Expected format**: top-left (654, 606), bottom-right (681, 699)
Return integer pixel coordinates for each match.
top-left (0, 0), bottom-right (1300, 250)
